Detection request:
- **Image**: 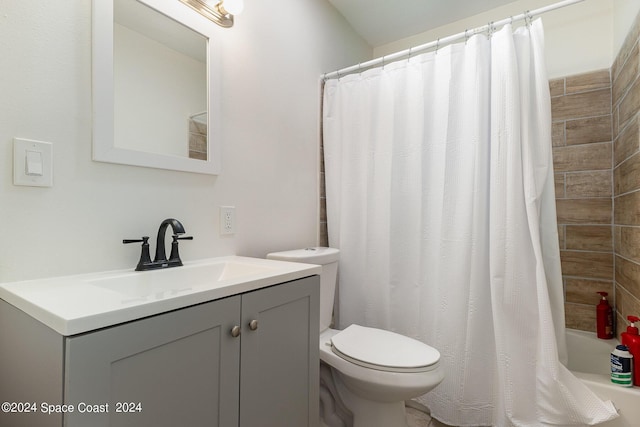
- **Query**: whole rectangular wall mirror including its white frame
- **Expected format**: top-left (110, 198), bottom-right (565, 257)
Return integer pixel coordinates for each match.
top-left (93, 0), bottom-right (220, 174)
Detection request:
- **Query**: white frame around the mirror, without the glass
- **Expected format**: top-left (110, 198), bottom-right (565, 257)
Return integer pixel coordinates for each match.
top-left (92, 0), bottom-right (222, 175)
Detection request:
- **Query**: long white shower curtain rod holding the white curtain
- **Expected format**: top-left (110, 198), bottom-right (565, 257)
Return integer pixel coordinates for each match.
top-left (322, 0), bottom-right (584, 80)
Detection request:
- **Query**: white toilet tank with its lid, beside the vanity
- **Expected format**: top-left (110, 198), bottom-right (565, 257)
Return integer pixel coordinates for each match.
top-left (267, 247), bottom-right (340, 332)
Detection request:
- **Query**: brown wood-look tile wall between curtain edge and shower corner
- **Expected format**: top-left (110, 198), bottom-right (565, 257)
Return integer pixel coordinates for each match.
top-left (549, 70), bottom-right (614, 331)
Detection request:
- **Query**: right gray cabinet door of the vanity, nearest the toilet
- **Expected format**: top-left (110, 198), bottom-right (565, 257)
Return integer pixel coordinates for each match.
top-left (240, 276), bottom-right (320, 427)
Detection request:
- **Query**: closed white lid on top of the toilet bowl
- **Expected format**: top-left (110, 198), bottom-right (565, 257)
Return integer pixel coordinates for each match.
top-left (331, 325), bottom-right (440, 372)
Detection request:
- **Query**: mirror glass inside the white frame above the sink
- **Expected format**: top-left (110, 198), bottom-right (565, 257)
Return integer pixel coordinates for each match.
top-left (113, 0), bottom-right (207, 160)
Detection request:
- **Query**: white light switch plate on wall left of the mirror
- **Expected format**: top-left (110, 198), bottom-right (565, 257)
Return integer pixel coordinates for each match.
top-left (13, 138), bottom-right (53, 187)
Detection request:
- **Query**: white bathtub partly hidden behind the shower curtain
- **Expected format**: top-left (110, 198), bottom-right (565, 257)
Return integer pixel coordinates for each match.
top-left (567, 329), bottom-right (640, 427)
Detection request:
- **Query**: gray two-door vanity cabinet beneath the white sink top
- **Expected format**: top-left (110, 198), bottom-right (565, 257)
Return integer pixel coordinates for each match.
top-left (0, 276), bottom-right (319, 427)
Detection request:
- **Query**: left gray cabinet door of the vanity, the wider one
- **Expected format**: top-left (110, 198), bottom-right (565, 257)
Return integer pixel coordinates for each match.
top-left (65, 296), bottom-right (240, 427)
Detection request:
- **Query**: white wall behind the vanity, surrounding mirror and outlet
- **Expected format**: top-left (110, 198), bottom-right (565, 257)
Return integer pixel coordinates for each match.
top-left (0, 0), bottom-right (371, 282)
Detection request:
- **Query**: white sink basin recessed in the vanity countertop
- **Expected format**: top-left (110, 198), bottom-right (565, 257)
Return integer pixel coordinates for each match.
top-left (87, 259), bottom-right (277, 301)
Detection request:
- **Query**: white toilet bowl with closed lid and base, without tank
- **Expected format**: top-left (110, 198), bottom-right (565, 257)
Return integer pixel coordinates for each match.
top-left (320, 325), bottom-right (444, 427)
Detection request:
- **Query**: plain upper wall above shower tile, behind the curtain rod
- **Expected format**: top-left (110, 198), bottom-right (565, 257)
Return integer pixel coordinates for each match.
top-left (374, 0), bottom-right (616, 78)
